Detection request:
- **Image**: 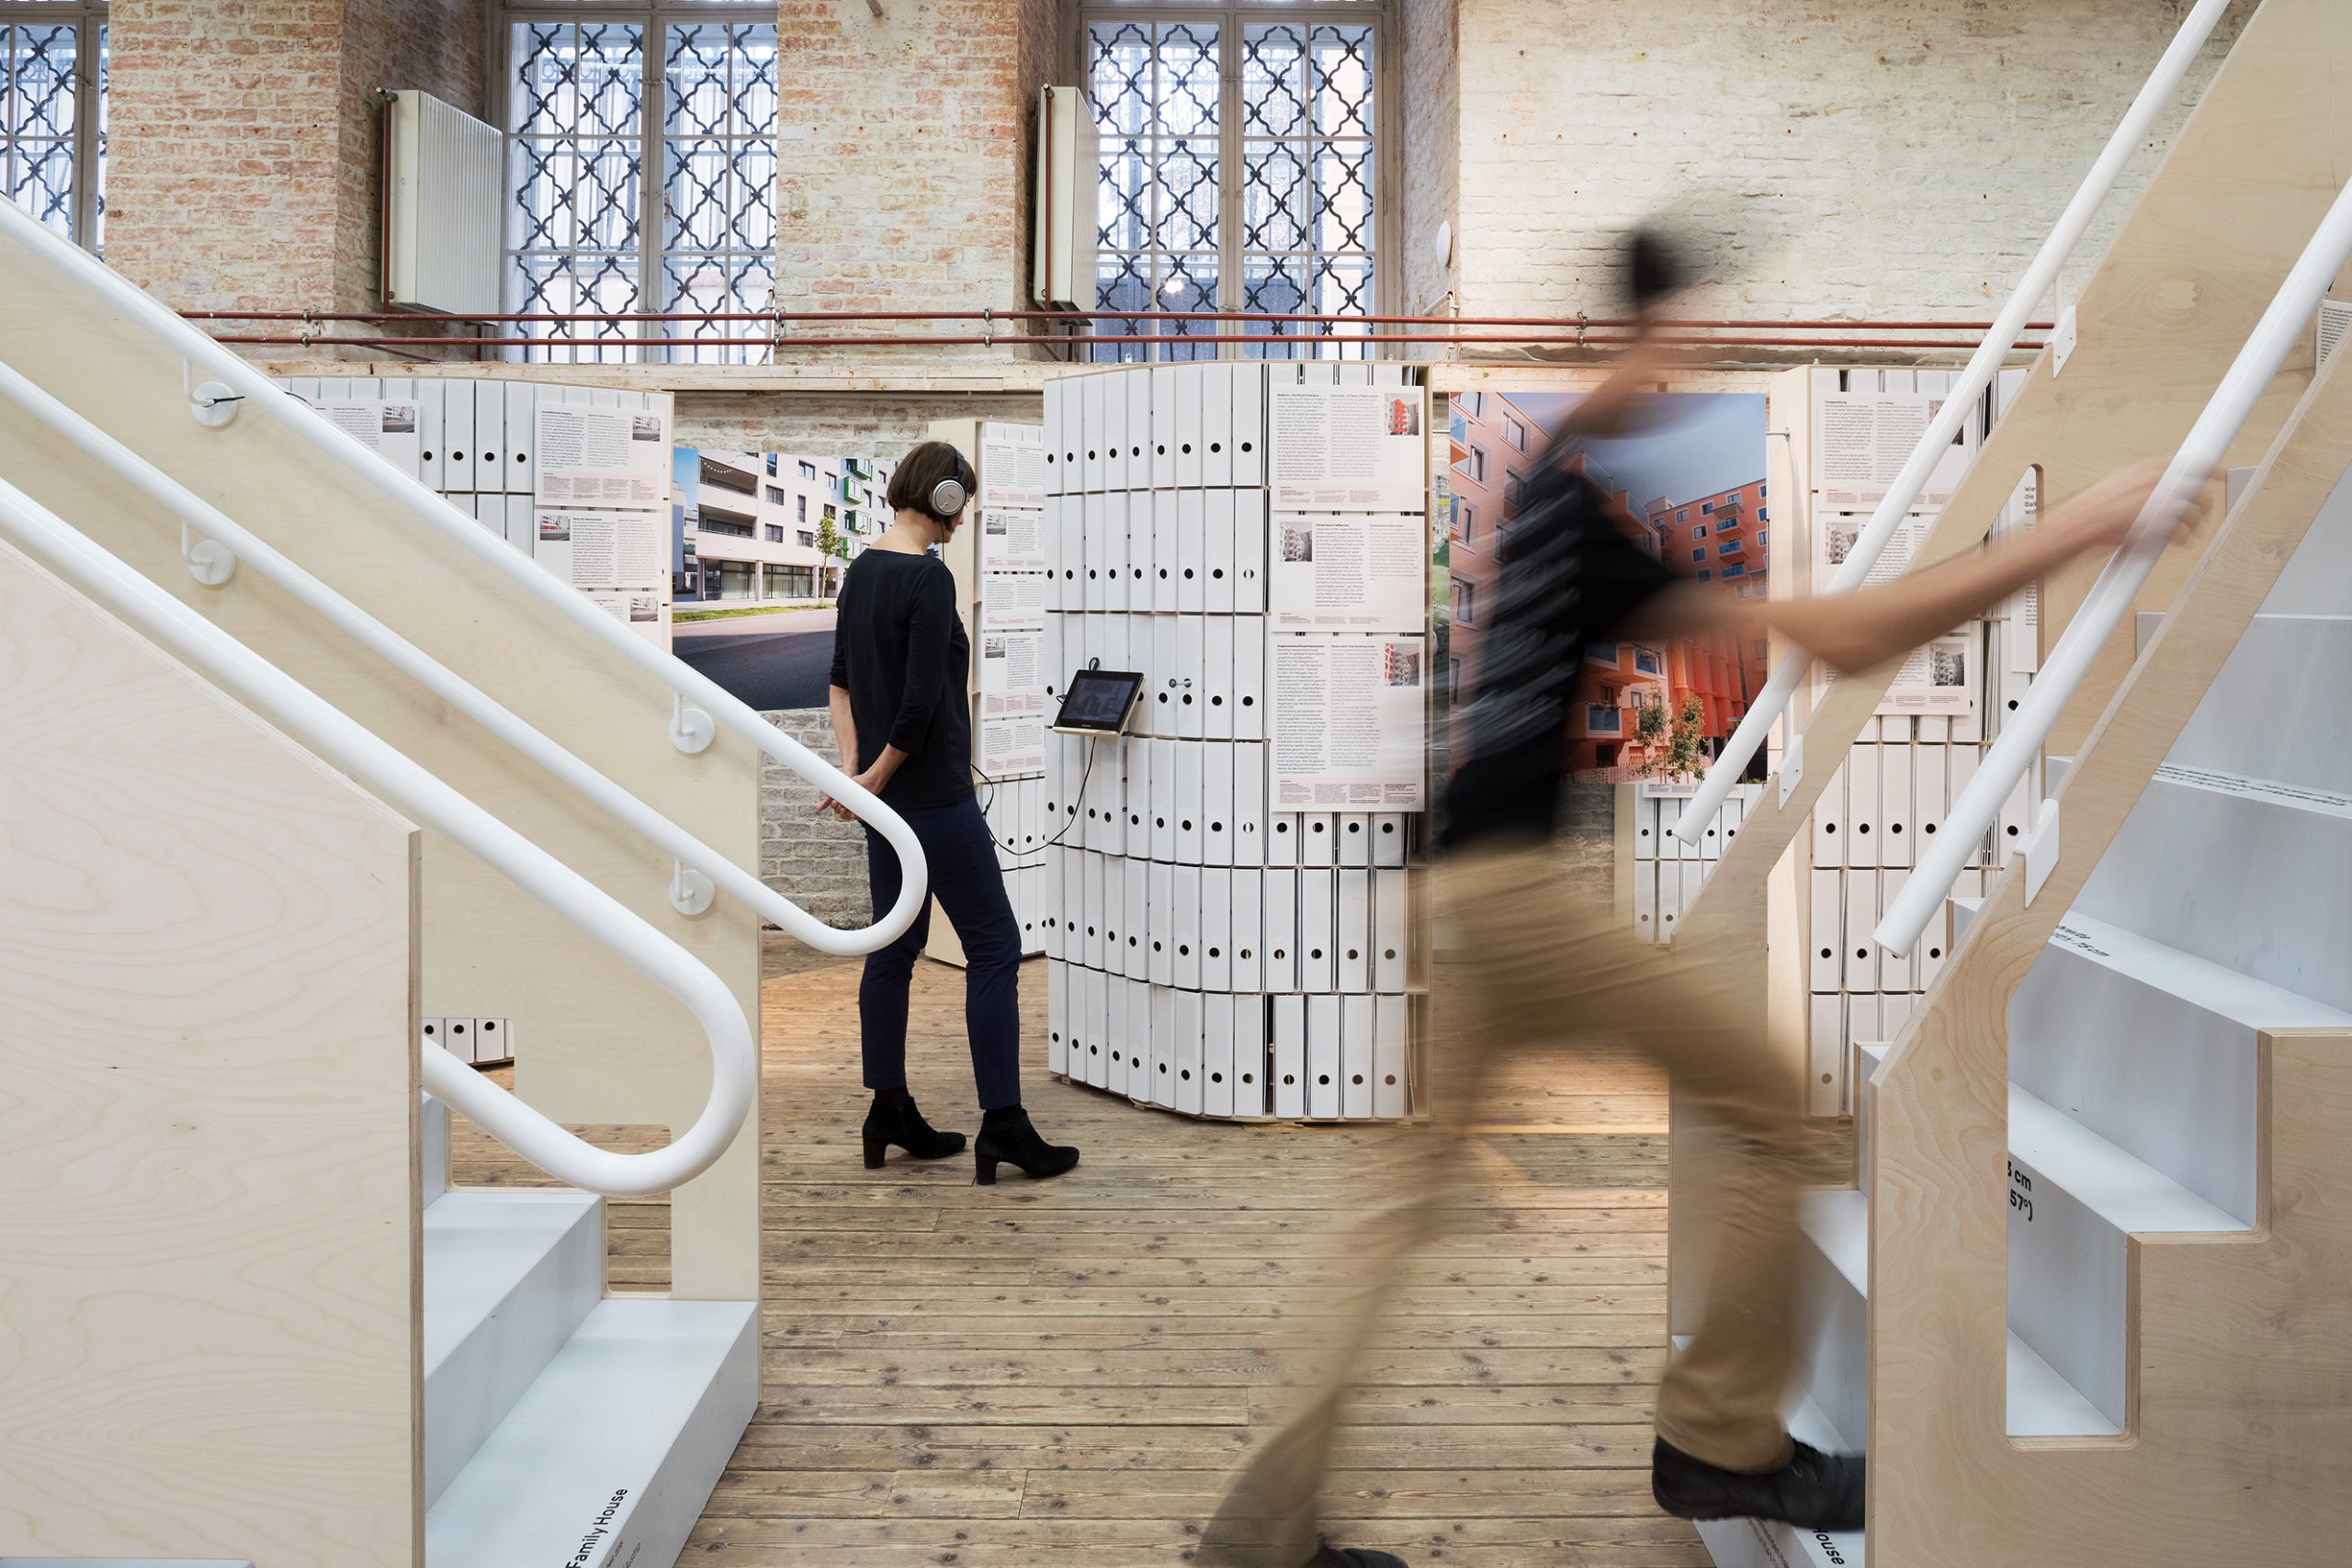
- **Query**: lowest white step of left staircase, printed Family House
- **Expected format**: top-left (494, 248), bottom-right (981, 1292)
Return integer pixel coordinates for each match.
top-left (425, 1298), bottom-right (760, 1568)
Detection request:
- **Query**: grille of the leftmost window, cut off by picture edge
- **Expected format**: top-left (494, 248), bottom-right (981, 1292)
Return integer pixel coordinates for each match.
top-left (0, 0), bottom-right (106, 254)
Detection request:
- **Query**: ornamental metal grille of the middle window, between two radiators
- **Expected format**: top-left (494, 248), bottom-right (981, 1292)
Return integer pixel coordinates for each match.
top-left (503, 0), bottom-right (776, 365)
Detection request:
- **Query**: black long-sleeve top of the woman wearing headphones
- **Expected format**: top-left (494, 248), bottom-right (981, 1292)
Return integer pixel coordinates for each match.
top-left (832, 550), bottom-right (971, 811)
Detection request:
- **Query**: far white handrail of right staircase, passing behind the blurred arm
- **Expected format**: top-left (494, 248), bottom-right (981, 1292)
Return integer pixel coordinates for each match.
top-left (1675, 0), bottom-right (2230, 844)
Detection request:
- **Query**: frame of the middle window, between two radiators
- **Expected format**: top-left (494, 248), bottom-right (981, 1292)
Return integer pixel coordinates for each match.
top-left (498, 0), bottom-right (783, 365)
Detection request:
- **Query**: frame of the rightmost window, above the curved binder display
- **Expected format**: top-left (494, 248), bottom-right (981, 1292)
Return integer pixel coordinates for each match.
top-left (1077, 0), bottom-right (1407, 365)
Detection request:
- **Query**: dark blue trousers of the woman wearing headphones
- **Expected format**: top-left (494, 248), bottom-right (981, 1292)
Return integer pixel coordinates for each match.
top-left (858, 799), bottom-right (1021, 1110)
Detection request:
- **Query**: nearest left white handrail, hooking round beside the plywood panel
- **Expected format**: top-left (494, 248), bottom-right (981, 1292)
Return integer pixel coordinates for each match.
top-left (0, 479), bottom-right (760, 1197)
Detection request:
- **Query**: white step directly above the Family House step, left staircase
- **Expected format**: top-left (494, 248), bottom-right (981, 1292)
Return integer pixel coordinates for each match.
top-left (424, 1190), bottom-right (605, 1506)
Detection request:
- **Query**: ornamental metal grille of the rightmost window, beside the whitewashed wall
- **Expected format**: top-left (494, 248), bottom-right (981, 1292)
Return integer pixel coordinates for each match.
top-left (1082, 0), bottom-right (1395, 360)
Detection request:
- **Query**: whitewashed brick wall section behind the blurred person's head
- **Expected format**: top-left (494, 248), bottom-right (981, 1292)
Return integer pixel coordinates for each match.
top-left (1456, 0), bottom-right (2244, 317)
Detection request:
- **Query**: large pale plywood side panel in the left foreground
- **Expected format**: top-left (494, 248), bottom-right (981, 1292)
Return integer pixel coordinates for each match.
top-left (0, 546), bottom-right (421, 1568)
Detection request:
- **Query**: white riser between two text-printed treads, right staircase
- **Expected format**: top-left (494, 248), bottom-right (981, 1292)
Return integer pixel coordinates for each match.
top-left (2075, 766), bottom-right (2352, 1009)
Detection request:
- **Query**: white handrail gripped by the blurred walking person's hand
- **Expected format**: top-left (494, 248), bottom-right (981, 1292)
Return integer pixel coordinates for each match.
top-left (1874, 171), bottom-right (2352, 954)
